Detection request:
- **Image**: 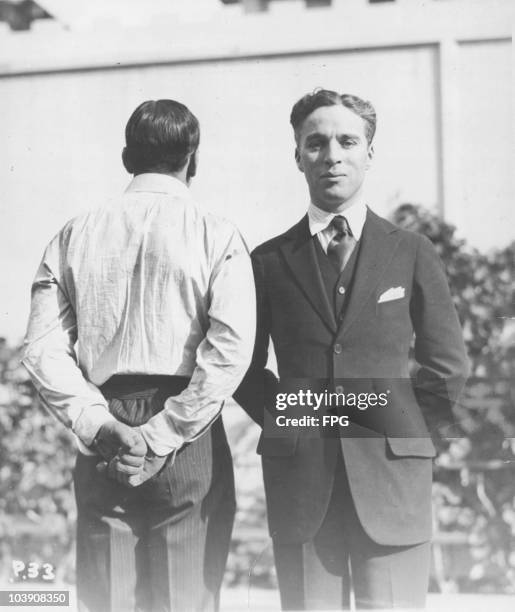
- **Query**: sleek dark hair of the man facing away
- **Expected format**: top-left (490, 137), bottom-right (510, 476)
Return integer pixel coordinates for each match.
top-left (123, 100), bottom-right (200, 174)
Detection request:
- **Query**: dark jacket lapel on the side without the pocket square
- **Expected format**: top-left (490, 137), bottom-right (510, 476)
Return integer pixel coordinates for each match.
top-left (281, 215), bottom-right (337, 333)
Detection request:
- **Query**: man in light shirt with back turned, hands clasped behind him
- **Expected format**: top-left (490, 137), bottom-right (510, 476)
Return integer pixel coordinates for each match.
top-left (23, 100), bottom-right (255, 612)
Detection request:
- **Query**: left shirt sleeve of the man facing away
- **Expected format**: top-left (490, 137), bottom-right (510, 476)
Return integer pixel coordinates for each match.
top-left (22, 234), bottom-right (114, 453)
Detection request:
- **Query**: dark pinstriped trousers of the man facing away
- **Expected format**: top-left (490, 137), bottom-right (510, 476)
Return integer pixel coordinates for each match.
top-left (75, 376), bottom-right (235, 612)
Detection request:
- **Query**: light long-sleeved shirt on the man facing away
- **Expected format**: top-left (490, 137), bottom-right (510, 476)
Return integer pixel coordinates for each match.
top-left (22, 173), bottom-right (255, 455)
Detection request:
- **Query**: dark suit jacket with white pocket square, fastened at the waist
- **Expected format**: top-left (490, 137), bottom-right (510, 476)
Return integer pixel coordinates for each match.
top-left (235, 210), bottom-right (468, 545)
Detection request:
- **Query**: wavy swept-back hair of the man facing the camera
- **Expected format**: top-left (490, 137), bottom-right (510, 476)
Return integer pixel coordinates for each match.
top-left (290, 89), bottom-right (376, 144)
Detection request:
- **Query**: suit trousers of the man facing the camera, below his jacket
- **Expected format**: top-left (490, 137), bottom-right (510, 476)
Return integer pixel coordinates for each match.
top-left (274, 448), bottom-right (430, 610)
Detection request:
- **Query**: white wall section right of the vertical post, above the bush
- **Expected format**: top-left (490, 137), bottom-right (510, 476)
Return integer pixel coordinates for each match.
top-left (449, 37), bottom-right (515, 246)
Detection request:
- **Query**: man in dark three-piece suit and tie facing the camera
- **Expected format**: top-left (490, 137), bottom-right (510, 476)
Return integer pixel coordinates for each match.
top-left (235, 90), bottom-right (468, 610)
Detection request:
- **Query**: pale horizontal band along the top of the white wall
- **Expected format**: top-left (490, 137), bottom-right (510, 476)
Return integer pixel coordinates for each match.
top-left (0, 0), bottom-right (515, 77)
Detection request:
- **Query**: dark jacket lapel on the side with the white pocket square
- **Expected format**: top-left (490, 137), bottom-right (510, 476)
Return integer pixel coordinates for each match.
top-left (339, 209), bottom-right (400, 336)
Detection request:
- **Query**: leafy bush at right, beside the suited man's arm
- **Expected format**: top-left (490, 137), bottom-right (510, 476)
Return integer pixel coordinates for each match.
top-left (393, 204), bottom-right (515, 592)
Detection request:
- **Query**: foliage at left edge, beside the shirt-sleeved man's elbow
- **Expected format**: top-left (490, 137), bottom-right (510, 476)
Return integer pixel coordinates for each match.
top-left (0, 339), bottom-right (76, 579)
